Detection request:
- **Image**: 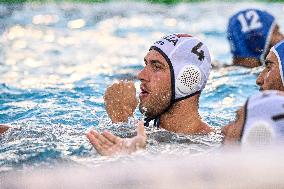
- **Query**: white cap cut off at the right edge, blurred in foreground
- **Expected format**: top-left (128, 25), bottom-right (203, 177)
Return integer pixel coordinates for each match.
top-left (241, 90), bottom-right (284, 145)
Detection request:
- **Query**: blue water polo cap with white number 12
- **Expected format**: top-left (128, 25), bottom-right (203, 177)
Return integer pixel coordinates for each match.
top-left (227, 9), bottom-right (275, 61)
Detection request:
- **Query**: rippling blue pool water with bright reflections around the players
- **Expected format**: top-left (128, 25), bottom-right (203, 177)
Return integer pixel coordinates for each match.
top-left (0, 2), bottom-right (284, 172)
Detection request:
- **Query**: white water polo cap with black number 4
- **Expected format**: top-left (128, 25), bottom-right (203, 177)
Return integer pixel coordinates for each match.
top-left (150, 34), bottom-right (212, 103)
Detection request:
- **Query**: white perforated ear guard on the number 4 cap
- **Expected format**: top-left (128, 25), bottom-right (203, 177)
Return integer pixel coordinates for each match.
top-left (176, 65), bottom-right (202, 96)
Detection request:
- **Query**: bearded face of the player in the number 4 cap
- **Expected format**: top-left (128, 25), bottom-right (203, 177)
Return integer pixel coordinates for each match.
top-left (138, 50), bottom-right (171, 118)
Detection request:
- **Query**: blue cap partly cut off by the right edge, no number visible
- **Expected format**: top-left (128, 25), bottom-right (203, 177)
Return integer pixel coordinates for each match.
top-left (270, 40), bottom-right (284, 86)
